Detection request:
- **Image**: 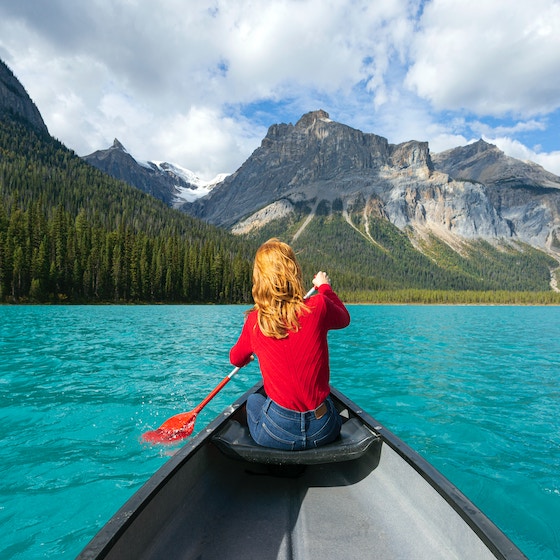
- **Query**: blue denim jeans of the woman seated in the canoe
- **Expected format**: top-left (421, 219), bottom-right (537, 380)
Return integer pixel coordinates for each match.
top-left (247, 393), bottom-right (342, 451)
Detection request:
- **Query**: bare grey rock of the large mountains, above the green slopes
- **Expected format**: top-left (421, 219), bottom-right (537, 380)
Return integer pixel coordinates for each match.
top-left (182, 111), bottom-right (560, 254)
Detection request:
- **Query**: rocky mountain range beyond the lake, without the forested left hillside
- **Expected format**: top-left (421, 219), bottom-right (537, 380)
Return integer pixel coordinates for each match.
top-left (0, 57), bottom-right (560, 300)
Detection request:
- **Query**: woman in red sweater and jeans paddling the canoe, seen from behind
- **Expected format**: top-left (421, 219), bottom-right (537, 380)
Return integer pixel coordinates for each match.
top-left (230, 238), bottom-right (350, 451)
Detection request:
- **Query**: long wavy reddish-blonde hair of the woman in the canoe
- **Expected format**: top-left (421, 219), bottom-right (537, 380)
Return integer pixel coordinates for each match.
top-left (252, 237), bottom-right (309, 338)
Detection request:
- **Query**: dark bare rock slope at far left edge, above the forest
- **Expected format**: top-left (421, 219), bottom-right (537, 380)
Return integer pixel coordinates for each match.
top-left (0, 60), bottom-right (49, 134)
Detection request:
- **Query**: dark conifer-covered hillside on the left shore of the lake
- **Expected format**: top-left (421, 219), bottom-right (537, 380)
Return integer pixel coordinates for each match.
top-left (0, 117), bottom-right (253, 303)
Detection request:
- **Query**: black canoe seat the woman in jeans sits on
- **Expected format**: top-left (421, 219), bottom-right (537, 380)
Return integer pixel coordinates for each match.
top-left (212, 418), bottom-right (380, 465)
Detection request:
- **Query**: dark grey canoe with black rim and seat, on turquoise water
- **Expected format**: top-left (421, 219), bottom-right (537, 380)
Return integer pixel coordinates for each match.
top-left (78, 384), bottom-right (526, 560)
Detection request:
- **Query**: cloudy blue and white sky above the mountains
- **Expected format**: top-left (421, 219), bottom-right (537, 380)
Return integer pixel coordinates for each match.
top-left (0, 0), bottom-right (560, 180)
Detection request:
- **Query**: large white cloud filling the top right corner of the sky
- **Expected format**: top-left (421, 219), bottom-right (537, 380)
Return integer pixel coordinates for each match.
top-left (406, 0), bottom-right (560, 116)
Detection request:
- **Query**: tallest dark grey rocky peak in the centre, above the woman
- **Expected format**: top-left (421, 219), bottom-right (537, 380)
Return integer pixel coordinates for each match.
top-left (183, 110), bottom-right (433, 227)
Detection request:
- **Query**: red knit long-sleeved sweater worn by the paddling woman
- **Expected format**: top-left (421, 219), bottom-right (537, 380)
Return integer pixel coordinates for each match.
top-left (230, 284), bottom-right (350, 412)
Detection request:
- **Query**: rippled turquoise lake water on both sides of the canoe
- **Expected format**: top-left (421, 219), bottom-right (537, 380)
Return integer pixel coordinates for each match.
top-left (0, 306), bottom-right (560, 560)
